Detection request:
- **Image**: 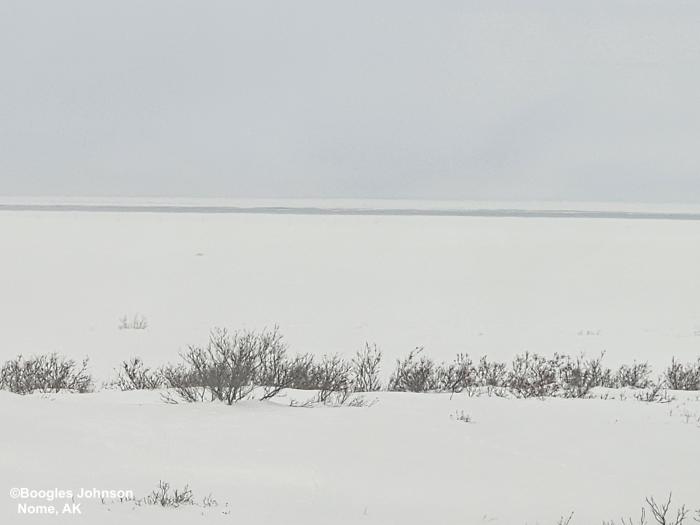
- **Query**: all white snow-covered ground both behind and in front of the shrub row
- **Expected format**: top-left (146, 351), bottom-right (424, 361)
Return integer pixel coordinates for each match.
top-left (0, 207), bottom-right (700, 525)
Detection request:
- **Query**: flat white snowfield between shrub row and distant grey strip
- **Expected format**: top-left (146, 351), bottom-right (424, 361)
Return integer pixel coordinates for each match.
top-left (0, 205), bottom-right (700, 378)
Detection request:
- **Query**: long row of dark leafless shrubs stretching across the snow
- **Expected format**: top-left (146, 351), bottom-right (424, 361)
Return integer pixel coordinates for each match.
top-left (0, 328), bottom-right (700, 398)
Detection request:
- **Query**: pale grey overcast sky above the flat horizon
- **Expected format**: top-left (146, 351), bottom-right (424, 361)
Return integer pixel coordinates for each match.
top-left (0, 0), bottom-right (700, 202)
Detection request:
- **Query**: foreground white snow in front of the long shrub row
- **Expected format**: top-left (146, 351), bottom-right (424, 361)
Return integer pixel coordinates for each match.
top-left (0, 391), bottom-right (700, 525)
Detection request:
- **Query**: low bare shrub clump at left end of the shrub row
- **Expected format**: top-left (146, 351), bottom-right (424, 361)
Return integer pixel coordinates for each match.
top-left (0, 353), bottom-right (93, 394)
